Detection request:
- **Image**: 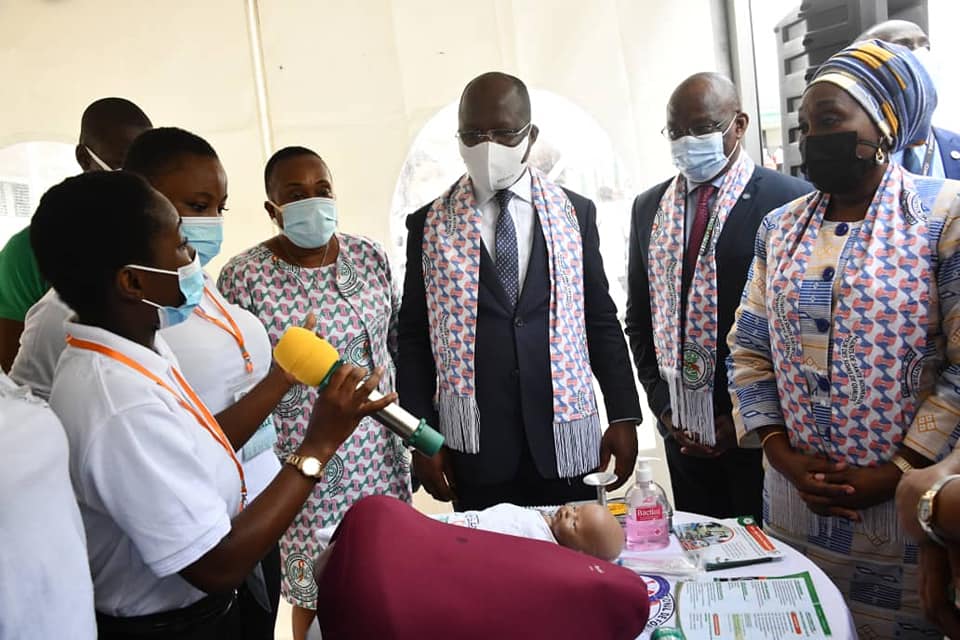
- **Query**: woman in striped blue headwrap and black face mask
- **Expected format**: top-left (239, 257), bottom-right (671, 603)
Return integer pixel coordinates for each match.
top-left (729, 41), bottom-right (960, 638)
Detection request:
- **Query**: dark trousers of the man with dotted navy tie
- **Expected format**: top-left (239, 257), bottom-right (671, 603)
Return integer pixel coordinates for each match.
top-left (453, 447), bottom-right (597, 511)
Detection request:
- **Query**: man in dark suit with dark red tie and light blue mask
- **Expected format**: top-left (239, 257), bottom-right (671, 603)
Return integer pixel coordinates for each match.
top-left (626, 73), bottom-right (812, 518)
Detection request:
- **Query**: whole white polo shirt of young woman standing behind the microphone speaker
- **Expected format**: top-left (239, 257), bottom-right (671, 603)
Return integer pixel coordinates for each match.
top-left (10, 278), bottom-right (280, 500)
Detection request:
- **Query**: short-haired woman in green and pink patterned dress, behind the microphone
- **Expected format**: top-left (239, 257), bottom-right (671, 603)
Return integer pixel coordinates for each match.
top-left (218, 147), bottom-right (410, 640)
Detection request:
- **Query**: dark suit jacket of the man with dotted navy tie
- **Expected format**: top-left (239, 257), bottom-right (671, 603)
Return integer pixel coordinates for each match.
top-left (397, 191), bottom-right (641, 485)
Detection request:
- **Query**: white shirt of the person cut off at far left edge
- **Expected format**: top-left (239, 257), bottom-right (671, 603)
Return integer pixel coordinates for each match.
top-left (0, 372), bottom-right (97, 640)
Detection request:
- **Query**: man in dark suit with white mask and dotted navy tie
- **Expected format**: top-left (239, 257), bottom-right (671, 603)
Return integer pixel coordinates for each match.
top-left (397, 73), bottom-right (641, 510)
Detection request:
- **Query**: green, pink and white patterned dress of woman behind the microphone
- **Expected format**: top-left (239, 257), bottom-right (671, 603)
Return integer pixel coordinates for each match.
top-left (218, 234), bottom-right (411, 609)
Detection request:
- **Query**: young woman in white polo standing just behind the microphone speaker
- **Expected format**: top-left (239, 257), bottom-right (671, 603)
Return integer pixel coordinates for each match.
top-left (10, 127), bottom-right (302, 640)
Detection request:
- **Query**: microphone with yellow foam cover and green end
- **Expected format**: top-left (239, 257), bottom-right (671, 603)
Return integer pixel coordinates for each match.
top-left (273, 327), bottom-right (443, 457)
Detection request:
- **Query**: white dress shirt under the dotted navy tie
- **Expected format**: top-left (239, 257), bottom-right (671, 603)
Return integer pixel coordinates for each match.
top-left (471, 169), bottom-right (536, 291)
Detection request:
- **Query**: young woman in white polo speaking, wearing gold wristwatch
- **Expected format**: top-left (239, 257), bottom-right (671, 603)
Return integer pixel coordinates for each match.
top-left (30, 172), bottom-right (395, 640)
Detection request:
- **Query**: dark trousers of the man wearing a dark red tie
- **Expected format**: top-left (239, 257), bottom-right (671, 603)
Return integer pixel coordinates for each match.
top-left (663, 438), bottom-right (763, 522)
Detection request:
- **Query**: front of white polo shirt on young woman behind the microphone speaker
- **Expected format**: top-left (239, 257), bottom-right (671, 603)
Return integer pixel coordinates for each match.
top-left (160, 278), bottom-right (280, 500)
